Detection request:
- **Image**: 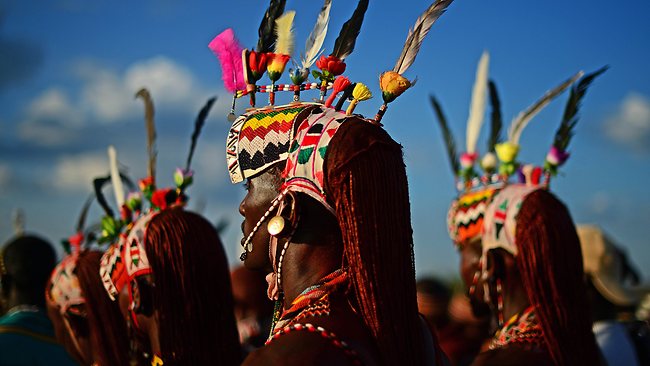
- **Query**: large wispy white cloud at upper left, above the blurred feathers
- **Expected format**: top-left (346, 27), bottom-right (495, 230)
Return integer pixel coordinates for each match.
top-left (18, 56), bottom-right (220, 147)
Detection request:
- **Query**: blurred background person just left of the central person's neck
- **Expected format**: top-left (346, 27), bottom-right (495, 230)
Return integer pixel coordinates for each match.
top-left (230, 266), bottom-right (273, 355)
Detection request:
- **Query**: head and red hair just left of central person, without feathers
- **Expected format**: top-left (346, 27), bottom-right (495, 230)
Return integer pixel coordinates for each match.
top-left (124, 208), bottom-right (241, 365)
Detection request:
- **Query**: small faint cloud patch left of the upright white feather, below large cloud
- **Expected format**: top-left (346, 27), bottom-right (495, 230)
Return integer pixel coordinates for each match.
top-left (53, 152), bottom-right (108, 192)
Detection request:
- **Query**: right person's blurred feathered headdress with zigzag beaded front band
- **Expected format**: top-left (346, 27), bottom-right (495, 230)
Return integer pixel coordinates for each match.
top-left (431, 53), bottom-right (606, 245)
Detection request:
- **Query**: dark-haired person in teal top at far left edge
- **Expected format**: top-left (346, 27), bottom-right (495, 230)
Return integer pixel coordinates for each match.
top-left (0, 234), bottom-right (75, 365)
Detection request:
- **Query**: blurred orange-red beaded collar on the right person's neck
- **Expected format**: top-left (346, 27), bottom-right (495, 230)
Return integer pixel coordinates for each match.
top-left (490, 306), bottom-right (544, 350)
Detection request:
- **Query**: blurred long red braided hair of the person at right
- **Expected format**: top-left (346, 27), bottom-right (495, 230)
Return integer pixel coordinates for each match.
top-left (515, 190), bottom-right (600, 366)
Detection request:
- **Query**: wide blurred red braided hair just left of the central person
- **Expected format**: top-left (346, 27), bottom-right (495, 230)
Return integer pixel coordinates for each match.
top-left (144, 208), bottom-right (241, 366)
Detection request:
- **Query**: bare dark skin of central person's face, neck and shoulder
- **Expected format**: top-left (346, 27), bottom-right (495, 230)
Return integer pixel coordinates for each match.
top-left (239, 169), bottom-right (378, 365)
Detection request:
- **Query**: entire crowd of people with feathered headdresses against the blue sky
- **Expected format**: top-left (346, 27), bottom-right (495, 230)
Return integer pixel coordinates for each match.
top-left (0, 0), bottom-right (650, 366)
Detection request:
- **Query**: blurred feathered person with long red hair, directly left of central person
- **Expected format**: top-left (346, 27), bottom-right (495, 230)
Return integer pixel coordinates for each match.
top-left (110, 89), bottom-right (242, 365)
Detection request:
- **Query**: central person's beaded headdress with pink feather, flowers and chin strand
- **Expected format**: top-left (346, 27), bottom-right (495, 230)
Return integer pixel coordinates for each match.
top-left (218, 0), bottom-right (451, 260)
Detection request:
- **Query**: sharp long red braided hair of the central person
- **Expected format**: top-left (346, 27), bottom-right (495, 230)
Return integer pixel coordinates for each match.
top-left (325, 118), bottom-right (430, 365)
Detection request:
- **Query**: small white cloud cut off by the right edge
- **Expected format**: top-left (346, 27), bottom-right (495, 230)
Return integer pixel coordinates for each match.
top-left (604, 93), bottom-right (650, 151)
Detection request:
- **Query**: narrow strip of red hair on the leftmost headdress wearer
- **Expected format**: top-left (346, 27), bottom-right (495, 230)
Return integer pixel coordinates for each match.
top-left (76, 250), bottom-right (129, 365)
